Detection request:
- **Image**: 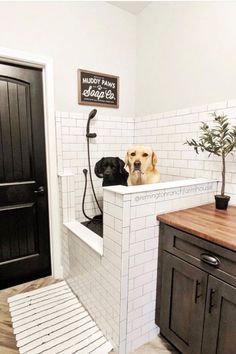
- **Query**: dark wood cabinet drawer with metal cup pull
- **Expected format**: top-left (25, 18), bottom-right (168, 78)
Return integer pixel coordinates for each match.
top-left (161, 223), bottom-right (236, 286)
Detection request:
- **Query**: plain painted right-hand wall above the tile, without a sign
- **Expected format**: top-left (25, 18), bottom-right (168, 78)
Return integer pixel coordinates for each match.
top-left (136, 1), bottom-right (236, 115)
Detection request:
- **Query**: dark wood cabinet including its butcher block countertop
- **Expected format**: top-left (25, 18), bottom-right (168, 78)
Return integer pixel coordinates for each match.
top-left (156, 204), bottom-right (236, 354)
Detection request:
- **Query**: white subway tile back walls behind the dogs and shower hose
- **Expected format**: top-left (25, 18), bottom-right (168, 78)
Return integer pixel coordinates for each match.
top-left (56, 100), bottom-right (236, 221)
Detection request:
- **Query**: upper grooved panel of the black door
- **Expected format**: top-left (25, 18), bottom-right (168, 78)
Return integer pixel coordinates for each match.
top-left (0, 76), bottom-right (33, 183)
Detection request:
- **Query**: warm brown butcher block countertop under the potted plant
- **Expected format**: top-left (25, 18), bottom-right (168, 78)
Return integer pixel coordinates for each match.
top-left (157, 204), bottom-right (236, 251)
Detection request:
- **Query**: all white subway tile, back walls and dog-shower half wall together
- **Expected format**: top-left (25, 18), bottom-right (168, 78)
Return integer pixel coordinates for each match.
top-left (56, 100), bottom-right (236, 354)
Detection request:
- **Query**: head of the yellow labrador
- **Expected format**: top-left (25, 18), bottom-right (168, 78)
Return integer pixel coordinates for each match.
top-left (125, 145), bottom-right (157, 174)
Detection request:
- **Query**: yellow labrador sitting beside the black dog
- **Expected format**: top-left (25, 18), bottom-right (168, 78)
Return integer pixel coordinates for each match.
top-left (125, 145), bottom-right (160, 186)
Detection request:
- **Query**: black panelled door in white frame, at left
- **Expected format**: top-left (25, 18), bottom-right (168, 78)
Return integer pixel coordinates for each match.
top-left (0, 63), bottom-right (51, 289)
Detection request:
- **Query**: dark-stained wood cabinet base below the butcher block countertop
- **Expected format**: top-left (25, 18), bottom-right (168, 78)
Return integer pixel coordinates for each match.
top-left (156, 224), bottom-right (236, 354)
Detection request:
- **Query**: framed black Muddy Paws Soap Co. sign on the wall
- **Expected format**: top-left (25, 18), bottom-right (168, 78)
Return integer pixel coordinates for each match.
top-left (78, 69), bottom-right (119, 108)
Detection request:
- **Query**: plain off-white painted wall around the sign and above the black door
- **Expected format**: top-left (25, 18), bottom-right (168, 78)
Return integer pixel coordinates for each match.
top-left (0, 1), bottom-right (136, 115)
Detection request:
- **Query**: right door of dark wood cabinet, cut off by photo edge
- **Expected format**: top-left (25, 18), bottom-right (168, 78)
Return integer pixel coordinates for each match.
top-left (202, 276), bottom-right (236, 354)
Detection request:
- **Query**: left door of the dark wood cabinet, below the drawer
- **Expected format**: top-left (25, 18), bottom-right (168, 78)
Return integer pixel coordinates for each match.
top-left (160, 252), bottom-right (207, 354)
